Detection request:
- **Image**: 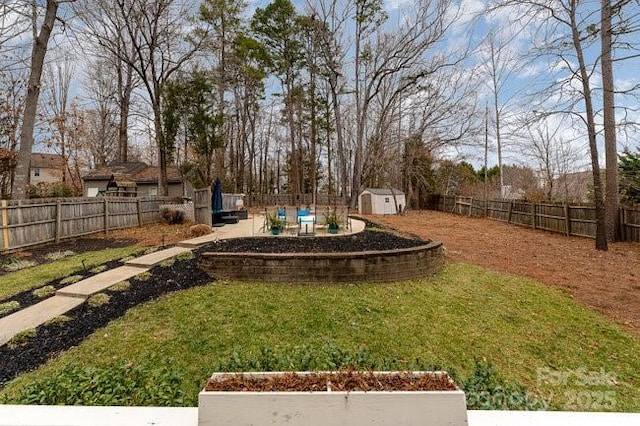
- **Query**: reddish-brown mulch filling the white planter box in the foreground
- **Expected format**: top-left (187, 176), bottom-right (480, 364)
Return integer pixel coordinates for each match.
top-left (205, 370), bottom-right (458, 392)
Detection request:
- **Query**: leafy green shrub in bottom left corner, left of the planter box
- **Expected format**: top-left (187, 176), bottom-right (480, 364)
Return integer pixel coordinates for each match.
top-left (10, 364), bottom-right (184, 406)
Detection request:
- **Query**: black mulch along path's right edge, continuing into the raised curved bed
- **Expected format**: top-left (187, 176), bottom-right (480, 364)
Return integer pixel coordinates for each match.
top-left (0, 230), bottom-right (425, 387)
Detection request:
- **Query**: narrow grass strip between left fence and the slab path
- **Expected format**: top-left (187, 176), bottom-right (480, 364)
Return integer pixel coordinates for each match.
top-left (0, 247), bottom-right (140, 298)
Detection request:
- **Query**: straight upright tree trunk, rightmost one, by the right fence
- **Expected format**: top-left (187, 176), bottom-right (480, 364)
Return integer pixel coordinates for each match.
top-left (601, 0), bottom-right (620, 241)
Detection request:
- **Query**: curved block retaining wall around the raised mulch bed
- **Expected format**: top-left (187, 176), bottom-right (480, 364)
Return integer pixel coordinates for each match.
top-left (200, 242), bottom-right (444, 284)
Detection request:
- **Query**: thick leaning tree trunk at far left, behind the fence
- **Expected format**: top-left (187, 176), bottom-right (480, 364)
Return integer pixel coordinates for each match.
top-left (12, 0), bottom-right (58, 200)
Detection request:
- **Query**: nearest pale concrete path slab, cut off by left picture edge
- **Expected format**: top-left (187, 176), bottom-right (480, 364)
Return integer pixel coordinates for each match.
top-left (0, 295), bottom-right (84, 346)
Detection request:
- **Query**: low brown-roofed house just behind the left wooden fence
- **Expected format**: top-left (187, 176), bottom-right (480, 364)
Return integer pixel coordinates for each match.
top-left (82, 162), bottom-right (193, 197)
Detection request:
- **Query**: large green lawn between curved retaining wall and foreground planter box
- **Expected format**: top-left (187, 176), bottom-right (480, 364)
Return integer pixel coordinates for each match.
top-left (5, 263), bottom-right (640, 411)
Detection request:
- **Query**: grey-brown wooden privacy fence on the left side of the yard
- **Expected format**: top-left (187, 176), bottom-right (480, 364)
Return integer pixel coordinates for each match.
top-left (0, 197), bottom-right (170, 251)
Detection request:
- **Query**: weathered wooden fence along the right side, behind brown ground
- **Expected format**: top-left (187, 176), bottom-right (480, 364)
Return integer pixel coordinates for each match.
top-left (429, 195), bottom-right (640, 242)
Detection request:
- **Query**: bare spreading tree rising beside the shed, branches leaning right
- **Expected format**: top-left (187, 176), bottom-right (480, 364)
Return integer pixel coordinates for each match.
top-left (350, 0), bottom-right (467, 207)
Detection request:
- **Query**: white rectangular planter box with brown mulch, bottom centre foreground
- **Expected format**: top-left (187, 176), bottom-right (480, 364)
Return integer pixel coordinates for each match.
top-left (198, 371), bottom-right (467, 426)
